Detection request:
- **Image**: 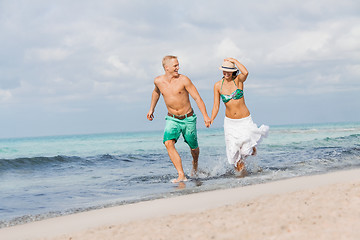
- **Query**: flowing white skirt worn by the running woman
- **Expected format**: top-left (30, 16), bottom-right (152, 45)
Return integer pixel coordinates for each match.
top-left (224, 115), bottom-right (269, 165)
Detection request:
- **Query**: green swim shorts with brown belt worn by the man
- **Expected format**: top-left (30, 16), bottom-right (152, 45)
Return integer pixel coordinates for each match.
top-left (163, 113), bottom-right (199, 149)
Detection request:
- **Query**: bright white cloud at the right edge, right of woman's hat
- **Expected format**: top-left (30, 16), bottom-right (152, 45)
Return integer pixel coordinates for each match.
top-left (267, 19), bottom-right (360, 64)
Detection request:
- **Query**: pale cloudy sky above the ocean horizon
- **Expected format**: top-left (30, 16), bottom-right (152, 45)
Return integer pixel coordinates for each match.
top-left (0, 0), bottom-right (360, 138)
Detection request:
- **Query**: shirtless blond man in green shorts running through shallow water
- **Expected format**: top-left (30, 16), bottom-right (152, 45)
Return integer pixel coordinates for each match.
top-left (147, 56), bottom-right (210, 183)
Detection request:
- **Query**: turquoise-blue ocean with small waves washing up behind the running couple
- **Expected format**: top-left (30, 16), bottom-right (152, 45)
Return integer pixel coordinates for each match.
top-left (0, 122), bottom-right (360, 227)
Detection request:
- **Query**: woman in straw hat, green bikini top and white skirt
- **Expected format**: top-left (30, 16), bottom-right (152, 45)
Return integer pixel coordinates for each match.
top-left (211, 58), bottom-right (269, 172)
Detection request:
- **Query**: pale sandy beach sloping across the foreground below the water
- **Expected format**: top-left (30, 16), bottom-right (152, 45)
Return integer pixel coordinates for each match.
top-left (0, 169), bottom-right (360, 240)
